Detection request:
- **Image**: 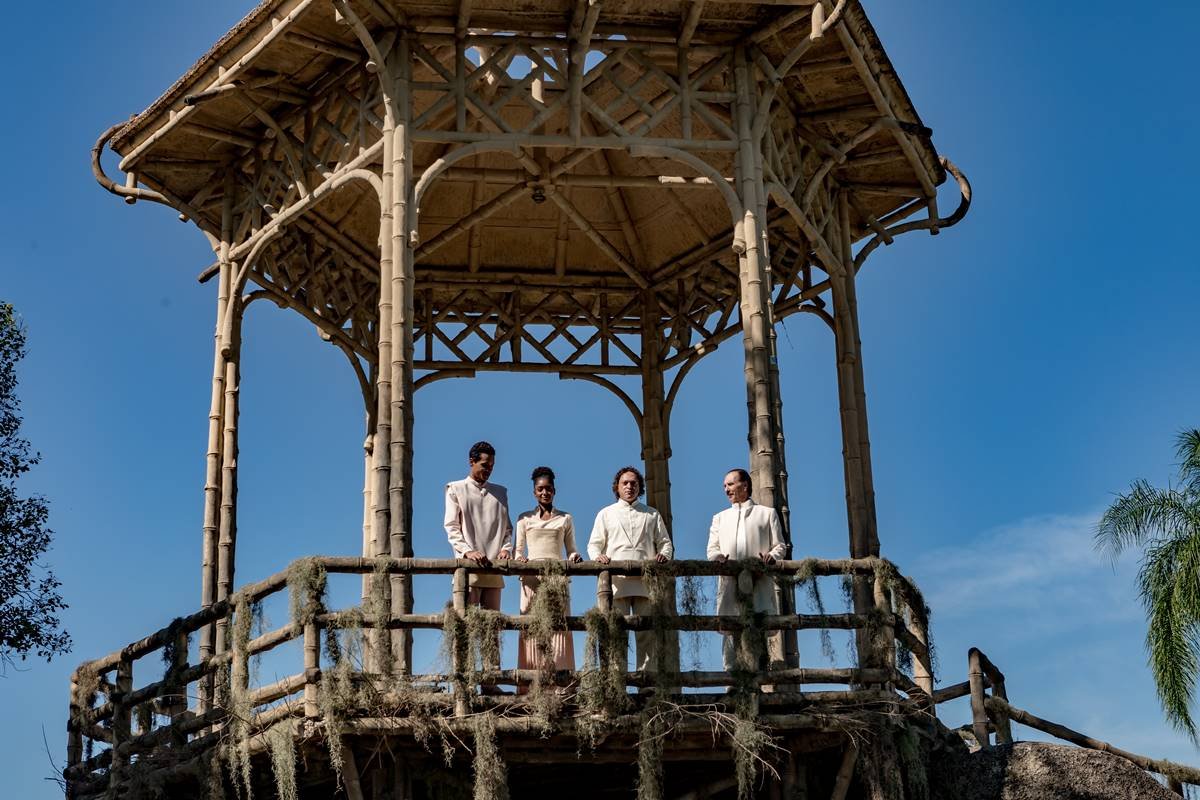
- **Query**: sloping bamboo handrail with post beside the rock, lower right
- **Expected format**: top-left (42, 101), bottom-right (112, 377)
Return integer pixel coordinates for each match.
top-left (934, 648), bottom-right (1200, 796)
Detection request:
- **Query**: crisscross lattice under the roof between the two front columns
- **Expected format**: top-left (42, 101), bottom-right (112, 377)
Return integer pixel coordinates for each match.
top-left (412, 34), bottom-right (737, 150)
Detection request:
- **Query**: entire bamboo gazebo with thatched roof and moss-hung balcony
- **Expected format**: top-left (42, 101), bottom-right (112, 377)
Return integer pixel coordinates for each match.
top-left (66, 0), bottom-right (982, 800)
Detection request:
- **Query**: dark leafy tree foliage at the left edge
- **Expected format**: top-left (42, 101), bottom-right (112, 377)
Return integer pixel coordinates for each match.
top-left (0, 302), bottom-right (71, 668)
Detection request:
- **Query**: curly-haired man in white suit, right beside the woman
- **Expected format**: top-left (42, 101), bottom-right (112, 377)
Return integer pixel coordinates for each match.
top-left (588, 467), bottom-right (674, 670)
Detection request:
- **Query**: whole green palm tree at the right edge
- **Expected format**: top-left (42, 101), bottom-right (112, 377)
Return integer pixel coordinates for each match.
top-left (1096, 428), bottom-right (1200, 741)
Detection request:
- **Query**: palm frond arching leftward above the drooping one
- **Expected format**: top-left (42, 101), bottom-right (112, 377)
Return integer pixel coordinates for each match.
top-left (1094, 480), bottom-right (1198, 559)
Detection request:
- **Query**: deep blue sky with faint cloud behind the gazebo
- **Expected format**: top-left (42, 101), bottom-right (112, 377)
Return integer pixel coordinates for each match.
top-left (0, 0), bottom-right (1200, 798)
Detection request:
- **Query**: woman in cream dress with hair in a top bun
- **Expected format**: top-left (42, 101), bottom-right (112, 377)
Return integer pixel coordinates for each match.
top-left (516, 467), bottom-right (583, 692)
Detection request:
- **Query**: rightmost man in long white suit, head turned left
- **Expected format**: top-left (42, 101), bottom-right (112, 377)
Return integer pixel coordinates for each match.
top-left (708, 469), bottom-right (787, 669)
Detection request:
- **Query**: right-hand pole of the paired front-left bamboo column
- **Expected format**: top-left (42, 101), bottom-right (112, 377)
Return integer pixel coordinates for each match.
top-left (391, 32), bottom-right (415, 674)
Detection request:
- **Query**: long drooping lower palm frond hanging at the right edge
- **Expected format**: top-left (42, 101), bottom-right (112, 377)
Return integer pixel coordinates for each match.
top-left (1138, 539), bottom-right (1200, 740)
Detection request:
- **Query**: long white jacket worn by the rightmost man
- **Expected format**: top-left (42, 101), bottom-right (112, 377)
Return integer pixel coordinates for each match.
top-left (708, 500), bottom-right (787, 614)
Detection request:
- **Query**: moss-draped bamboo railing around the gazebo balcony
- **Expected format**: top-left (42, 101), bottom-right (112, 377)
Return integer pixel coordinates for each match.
top-left (64, 557), bottom-right (935, 796)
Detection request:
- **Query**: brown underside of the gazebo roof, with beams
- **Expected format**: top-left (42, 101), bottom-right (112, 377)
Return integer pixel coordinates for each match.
top-left (98, 0), bottom-right (946, 355)
